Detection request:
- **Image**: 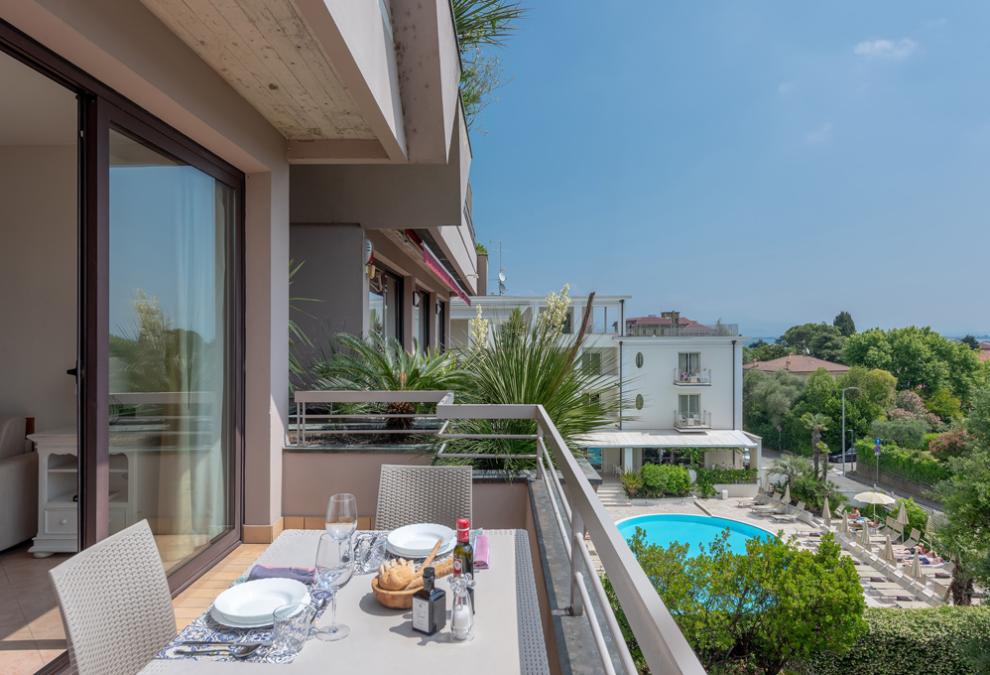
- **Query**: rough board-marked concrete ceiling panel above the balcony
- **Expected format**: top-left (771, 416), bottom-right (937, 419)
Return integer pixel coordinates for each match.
top-left (141, 0), bottom-right (376, 140)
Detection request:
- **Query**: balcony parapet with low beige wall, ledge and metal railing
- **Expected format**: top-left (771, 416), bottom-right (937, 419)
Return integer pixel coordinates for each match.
top-left (282, 391), bottom-right (704, 675)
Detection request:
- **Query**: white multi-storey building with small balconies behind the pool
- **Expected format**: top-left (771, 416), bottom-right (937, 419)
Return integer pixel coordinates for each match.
top-left (450, 295), bottom-right (762, 484)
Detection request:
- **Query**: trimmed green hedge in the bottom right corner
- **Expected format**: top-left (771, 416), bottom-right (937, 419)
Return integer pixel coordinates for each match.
top-left (802, 607), bottom-right (990, 675)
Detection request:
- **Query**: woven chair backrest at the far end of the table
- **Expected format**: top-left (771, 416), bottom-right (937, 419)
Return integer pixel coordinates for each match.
top-left (375, 464), bottom-right (474, 530)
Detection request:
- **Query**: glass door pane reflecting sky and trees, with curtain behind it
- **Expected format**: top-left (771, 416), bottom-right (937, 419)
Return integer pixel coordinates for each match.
top-left (107, 128), bottom-right (237, 569)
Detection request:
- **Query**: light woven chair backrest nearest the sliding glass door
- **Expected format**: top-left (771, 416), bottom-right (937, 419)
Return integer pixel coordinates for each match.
top-left (48, 520), bottom-right (175, 675)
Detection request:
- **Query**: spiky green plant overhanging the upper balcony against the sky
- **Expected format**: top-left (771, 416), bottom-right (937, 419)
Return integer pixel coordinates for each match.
top-left (451, 0), bottom-right (525, 126)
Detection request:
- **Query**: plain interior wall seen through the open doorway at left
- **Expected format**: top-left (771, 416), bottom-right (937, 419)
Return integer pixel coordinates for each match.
top-left (0, 148), bottom-right (78, 431)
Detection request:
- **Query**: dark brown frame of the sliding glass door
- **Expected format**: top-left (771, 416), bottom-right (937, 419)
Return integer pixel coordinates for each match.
top-left (0, 19), bottom-right (245, 596)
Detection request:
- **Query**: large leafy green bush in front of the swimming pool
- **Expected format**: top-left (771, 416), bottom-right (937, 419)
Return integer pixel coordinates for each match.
top-left (604, 530), bottom-right (866, 674)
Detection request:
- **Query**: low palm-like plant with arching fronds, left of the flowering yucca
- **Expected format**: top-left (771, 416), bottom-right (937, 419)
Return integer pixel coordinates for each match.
top-left (313, 333), bottom-right (465, 429)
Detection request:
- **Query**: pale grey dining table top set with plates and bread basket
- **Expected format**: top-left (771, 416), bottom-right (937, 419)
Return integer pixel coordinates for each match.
top-left (141, 530), bottom-right (549, 675)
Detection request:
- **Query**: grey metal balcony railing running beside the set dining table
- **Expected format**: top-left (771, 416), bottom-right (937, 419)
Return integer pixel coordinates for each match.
top-left (290, 391), bottom-right (705, 675)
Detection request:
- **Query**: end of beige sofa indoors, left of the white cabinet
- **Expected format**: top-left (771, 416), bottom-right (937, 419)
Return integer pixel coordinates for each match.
top-left (0, 417), bottom-right (38, 551)
